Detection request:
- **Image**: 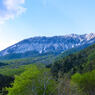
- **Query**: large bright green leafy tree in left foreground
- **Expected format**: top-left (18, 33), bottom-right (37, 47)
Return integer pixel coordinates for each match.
top-left (8, 65), bottom-right (56, 95)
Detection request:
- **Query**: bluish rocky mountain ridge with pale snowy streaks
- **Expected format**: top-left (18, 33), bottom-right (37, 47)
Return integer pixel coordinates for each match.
top-left (0, 33), bottom-right (95, 56)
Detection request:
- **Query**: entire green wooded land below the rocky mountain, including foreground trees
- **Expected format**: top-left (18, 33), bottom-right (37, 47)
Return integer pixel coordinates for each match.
top-left (0, 44), bottom-right (95, 95)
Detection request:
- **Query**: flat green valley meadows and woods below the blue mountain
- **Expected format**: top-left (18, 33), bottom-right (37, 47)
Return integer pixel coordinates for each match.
top-left (0, 54), bottom-right (55, 76)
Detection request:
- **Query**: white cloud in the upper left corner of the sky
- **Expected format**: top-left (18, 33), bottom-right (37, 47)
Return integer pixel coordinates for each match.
top-left (0, 0), bottom-right (26, 23)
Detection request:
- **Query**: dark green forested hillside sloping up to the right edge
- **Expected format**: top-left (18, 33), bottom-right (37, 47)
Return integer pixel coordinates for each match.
top-left (52, 44), bottom-right (95, 75)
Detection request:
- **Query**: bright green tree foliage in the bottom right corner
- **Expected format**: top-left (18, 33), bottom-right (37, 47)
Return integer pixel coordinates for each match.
top-left (72, 70), bottom-right (95, 95)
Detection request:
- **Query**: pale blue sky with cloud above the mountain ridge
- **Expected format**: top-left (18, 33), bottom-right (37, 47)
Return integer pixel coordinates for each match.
top-left (0, 0), bottom-right (95, 50)
